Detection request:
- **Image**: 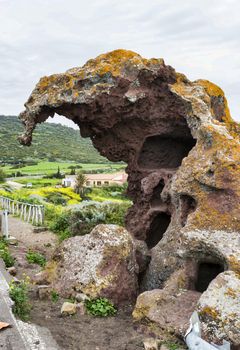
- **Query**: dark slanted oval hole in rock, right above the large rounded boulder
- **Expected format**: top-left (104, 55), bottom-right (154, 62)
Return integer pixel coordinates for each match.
top-left (146, 213), bottom-right (171, 249)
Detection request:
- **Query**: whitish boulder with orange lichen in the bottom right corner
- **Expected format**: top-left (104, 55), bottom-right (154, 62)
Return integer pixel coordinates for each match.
top-left (198, 271), bottom-right (240, 347)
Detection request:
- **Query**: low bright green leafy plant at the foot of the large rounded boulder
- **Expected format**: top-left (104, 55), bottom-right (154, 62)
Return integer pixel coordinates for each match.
top-left (84, 298), bottom-right (117, 317)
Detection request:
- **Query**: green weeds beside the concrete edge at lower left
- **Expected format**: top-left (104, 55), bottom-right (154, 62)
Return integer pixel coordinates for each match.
top-left (9, 277), bottom-right (31, 321)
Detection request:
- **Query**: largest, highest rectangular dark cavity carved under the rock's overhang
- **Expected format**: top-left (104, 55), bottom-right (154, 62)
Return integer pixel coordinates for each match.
top-left (138, 135), bottom-right (196, 169)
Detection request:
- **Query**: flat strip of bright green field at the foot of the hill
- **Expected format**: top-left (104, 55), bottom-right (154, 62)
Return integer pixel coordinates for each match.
top-left (3, 161), bottom-right (124, 176)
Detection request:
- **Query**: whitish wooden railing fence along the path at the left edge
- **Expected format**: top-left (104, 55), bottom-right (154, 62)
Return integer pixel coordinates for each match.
top-left (0, 196), bottom-right (44, 225)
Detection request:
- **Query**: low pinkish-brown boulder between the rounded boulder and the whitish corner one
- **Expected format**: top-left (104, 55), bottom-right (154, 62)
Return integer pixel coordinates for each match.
top-left (133, 270), bottom-right (201, 337)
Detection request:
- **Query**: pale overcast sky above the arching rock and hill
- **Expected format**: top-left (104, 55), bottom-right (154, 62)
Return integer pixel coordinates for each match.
top-left (0, 0), bottom-right (240, 127)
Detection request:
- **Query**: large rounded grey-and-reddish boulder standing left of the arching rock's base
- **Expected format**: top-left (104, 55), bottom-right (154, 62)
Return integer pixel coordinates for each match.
top-left (44, 225), bottom-right (138, 304)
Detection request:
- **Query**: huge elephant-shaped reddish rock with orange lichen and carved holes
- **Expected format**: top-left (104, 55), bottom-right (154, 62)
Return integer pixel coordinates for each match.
top-left (20, 50), bottom-right (240, 344)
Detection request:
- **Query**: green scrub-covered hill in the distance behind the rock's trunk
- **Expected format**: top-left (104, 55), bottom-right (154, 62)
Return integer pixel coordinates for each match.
top-left (0, 115), bottom-right (108, 163)
